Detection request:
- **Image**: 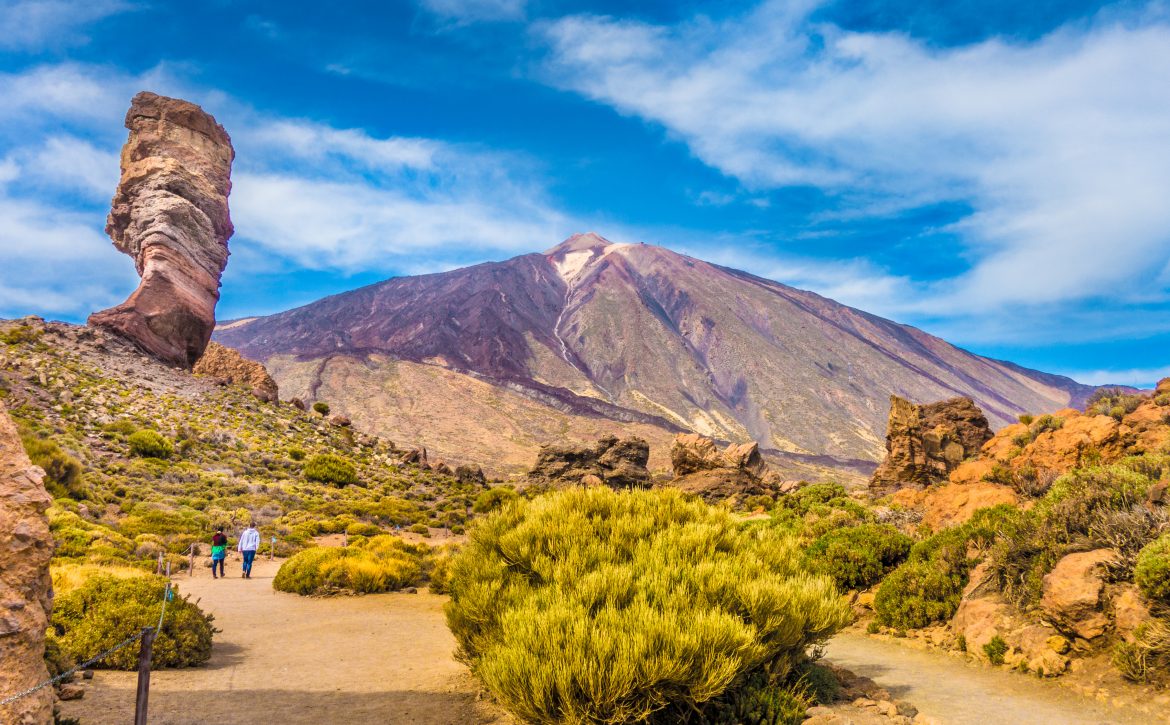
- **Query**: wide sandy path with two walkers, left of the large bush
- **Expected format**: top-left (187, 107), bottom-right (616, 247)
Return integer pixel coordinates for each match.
top-left (62, 560), bottom-right (507, 725)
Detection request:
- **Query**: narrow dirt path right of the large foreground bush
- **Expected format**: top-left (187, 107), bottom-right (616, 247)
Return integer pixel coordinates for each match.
top-left (825, 633), bottom-right (1170, 725)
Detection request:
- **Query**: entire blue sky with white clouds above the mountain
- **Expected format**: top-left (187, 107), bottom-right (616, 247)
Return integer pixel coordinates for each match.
top-left (0, 0), bottom-right (1170, 385)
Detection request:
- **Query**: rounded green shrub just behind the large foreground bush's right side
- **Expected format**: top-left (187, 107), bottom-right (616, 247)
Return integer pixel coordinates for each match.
top-left (806, 524), bottom-right (914, 591)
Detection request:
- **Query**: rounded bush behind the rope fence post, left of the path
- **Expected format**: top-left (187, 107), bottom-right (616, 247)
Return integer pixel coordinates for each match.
top-left (51, 574), bottom-right (216, 670)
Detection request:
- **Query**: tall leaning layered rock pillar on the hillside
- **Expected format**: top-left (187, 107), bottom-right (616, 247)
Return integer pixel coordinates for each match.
top-left (89, 91), bottom-right (235, 367)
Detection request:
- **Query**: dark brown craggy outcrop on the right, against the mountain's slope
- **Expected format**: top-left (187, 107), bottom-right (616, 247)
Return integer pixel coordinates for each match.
top-left (869, 395), bottom-right (992, 490)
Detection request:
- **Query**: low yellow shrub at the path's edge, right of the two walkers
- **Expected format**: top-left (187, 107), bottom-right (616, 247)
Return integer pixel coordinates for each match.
top-left (273, 536), bottom-right (422, 594)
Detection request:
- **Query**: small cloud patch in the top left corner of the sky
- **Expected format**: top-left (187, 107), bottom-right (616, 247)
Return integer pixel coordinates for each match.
top-left (0, 0), bottom-right (133, 50)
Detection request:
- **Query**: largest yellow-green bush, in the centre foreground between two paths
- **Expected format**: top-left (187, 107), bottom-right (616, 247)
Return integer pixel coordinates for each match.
top-left (447, 486), bottom-right (849, 723)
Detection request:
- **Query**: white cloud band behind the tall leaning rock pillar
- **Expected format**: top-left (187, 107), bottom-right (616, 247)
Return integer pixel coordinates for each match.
top-left (0, 64), bottom-right (572, 318)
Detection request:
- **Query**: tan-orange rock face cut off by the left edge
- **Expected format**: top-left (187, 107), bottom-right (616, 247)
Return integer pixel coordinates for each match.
top-left (0, 403), bottom-right (53, 725)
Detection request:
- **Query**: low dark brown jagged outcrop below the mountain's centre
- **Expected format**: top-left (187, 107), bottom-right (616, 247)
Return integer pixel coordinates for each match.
top-left (528, 436), bottom-right (651, 489)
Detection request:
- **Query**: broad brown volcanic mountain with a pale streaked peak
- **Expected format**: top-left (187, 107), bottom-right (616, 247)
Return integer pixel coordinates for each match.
top-left (215, 234), bottom-right (1094, 472)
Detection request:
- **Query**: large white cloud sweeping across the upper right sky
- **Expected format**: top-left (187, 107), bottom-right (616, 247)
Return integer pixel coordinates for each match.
top-left (541, 2), bottom-right (1170, 315)
